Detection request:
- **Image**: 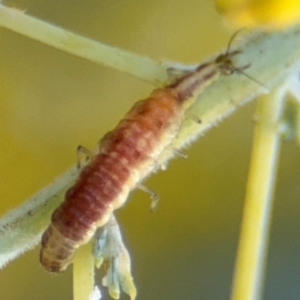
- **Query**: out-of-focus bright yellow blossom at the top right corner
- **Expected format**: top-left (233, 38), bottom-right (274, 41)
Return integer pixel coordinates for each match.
top-left (216, 0), bottom-right (300, 29)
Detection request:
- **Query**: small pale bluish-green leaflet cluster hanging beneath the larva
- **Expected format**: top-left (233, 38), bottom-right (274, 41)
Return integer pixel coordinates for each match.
top-left (93, 215), bottom-right (136, 300)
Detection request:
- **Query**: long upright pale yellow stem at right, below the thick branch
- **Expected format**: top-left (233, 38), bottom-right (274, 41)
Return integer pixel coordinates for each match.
top-left (231, 88), bottom-right (284, 300)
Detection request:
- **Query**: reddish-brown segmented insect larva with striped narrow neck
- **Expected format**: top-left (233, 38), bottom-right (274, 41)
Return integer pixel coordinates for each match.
top-left (40, 45), bottom-right (243, 272)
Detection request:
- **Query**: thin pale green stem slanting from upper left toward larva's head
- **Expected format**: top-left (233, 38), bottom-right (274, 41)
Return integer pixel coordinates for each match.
top-left (0, 4), bottom-right (167, 85)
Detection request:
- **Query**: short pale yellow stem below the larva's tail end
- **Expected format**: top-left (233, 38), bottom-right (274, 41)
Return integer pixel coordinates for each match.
top-left (73, 240), bottom-right (95, 300)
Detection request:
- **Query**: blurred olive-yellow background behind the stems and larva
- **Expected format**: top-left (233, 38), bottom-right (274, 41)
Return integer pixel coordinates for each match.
top-left (0, 0), bottom-right (300, 300)
